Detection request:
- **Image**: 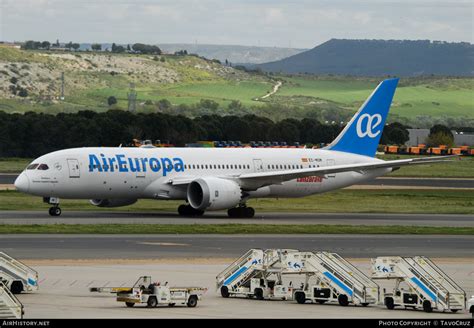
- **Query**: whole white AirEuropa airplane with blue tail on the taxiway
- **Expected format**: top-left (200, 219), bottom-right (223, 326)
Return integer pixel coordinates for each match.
top-left (15, 79), bottom-right (452, 218)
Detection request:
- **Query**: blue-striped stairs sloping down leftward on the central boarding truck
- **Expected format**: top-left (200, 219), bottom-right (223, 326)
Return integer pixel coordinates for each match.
top-left (216, 249), bottom-right (294, 291)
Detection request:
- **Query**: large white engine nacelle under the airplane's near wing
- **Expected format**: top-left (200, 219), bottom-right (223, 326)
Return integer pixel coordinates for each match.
top-left (187, 177), bottom-right (242, 210)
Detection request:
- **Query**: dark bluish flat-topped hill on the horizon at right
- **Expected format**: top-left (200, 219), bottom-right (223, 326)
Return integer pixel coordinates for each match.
top-left (256, 39), bottom-right (474, 77)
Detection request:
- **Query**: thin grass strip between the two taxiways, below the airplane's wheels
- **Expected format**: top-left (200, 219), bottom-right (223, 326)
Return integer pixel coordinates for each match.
top-left (0, 224), bottom-right (468, 235)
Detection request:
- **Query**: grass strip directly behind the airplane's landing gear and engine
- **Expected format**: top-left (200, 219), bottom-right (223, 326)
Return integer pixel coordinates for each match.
top-left (0, 190), bottom-right (474, 214)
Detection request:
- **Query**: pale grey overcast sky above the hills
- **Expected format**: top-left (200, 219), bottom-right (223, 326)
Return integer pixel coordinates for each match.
top-left (0, 0), bottom-right (474, 48)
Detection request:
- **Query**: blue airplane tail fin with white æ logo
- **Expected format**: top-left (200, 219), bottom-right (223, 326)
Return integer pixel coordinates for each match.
top-left (326, 79), bottom-right (398, 157)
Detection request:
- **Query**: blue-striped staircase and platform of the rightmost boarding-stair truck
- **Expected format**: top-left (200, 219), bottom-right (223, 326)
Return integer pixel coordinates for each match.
top-left (372, 256), bottom-right (466, 312)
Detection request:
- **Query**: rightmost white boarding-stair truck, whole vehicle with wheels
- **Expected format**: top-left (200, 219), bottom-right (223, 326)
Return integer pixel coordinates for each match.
top-left (372, 256), bottom-right (466, 312)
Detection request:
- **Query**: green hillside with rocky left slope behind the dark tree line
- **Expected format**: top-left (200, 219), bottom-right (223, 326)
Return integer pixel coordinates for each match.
top-left (0, 46), bottom-right (474, 126)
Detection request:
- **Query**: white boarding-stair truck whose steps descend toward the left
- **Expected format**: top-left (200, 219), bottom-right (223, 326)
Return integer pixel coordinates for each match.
top-left (216, 249), bottom-right (297, 300)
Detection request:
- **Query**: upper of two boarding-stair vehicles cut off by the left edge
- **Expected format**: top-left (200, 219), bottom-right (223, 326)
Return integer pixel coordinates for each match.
top-left (0, 252), bottom-right (39, 294)
